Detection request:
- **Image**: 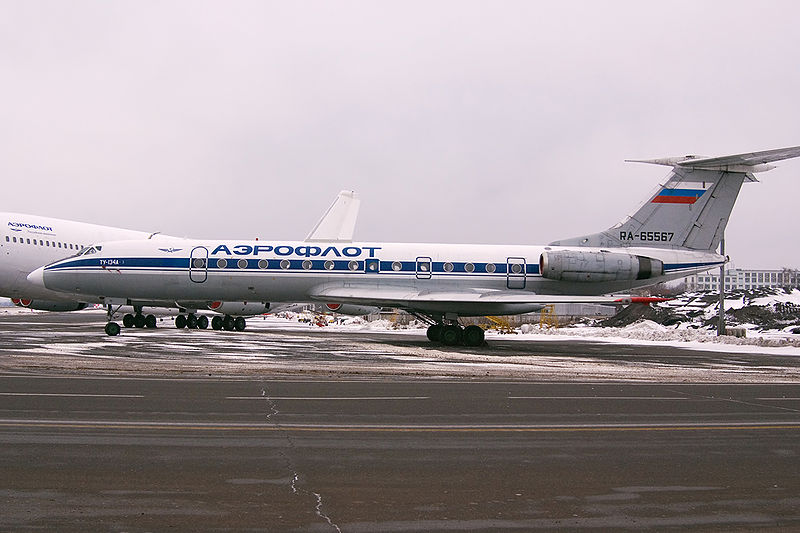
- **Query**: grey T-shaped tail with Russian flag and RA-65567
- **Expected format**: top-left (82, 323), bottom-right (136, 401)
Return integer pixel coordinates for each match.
top-left (551, 146), bottom-right (800, 251)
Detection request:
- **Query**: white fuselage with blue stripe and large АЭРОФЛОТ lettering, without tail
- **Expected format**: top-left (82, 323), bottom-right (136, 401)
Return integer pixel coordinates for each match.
top-left (40, 239), bottom-right (724, 316)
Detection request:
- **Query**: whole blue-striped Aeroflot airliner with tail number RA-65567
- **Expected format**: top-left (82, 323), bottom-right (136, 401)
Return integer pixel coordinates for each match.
top-left (28, 146), bottom-right (800, 346)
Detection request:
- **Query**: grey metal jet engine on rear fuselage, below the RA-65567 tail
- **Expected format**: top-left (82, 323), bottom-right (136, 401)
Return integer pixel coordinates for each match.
top-left (539, 251), bottom-right (664, 281)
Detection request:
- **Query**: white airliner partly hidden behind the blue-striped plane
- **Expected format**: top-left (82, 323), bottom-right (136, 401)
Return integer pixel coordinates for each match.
top-left (0, 187), bottom-right (361, 331)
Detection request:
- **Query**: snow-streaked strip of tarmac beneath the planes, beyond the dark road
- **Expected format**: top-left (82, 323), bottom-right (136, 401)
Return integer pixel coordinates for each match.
top-left (0, 311), bottom-right (800, 383)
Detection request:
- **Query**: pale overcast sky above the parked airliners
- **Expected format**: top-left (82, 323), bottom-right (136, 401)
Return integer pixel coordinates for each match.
top-left (0, 1), bottom-right (800, 268)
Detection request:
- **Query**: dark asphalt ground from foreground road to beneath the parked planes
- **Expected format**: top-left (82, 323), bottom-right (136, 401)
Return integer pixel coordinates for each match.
top-left (0, 310), bottom-right (800, 532)
